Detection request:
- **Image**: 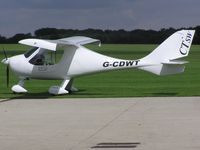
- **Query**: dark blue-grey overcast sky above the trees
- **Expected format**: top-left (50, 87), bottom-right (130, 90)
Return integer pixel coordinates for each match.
top-left (0, 0), bottom-right (200, 37)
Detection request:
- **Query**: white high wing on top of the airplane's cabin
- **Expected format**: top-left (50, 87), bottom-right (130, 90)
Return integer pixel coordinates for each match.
top-left (19, 36), bottom-right (101, 51)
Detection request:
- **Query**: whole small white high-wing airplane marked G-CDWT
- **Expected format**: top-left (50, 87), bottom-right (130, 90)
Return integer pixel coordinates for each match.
top-left (2, 30), bottom-right (195, 95)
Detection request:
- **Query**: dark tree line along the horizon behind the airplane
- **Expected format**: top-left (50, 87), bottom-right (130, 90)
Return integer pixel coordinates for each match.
top-left (0, 26), bottom-right (200, 44)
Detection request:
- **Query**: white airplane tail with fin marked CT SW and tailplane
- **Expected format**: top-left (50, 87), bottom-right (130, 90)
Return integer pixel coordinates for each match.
top-left (139, 30), bottom-right (195, 75)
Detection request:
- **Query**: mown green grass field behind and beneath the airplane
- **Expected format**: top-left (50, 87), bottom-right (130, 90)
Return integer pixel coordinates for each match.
top-left (0, 44), bottom-right (200, 98)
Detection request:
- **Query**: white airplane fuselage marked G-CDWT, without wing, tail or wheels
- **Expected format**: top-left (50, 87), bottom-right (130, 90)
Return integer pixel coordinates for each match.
top-left (9, 46), bottom-right (141, 79)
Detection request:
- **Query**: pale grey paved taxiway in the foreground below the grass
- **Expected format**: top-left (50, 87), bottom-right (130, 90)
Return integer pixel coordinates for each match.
top-left (0, 97), bottom-right (200, 150)
